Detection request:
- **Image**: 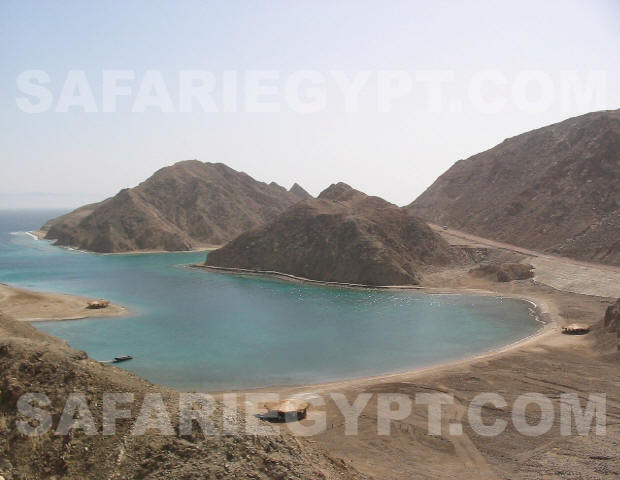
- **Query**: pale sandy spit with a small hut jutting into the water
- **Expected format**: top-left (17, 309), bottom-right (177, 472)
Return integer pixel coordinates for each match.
top-left (0, 283), bottom-right (129, 322)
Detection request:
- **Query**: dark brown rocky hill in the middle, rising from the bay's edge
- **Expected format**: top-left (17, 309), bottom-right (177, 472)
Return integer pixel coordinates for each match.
top-left (206, 183), bottom-right (453, 285)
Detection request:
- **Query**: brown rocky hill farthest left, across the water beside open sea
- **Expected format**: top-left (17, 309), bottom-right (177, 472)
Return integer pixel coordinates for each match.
top-left (42, 160), bottom-right (299, 252)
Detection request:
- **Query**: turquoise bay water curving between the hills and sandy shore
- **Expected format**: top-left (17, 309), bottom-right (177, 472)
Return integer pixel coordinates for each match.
top-left (0, 211), bottom-right (541, 391)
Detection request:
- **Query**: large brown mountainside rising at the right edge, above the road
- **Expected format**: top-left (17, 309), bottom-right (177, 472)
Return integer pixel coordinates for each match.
top-left (408, 110), bottom-right (620, 265)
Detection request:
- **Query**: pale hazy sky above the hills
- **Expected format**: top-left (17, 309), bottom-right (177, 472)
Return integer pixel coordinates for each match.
top-left (0, 0), bottom-right (620, 208)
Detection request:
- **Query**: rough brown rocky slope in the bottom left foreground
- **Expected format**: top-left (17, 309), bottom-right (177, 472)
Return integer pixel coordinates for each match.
top-left (0, 313), bottom-right (363, 480)
